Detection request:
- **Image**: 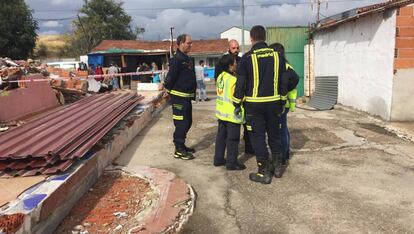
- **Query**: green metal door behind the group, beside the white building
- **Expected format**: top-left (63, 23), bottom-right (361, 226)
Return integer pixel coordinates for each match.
top-left (266, 27), bottom-right (308, 97)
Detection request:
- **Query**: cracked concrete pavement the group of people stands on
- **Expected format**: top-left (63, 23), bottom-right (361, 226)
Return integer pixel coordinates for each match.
top-left (117, 94), bottom-right (414, 233)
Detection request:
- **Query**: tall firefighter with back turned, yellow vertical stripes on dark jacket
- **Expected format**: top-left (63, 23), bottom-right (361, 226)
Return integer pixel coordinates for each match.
top-left (233, 25), bottom-right (288, 184)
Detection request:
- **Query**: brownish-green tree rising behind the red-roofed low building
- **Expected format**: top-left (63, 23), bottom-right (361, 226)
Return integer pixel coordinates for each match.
top-left (71, 0), bottom-right (140, 55)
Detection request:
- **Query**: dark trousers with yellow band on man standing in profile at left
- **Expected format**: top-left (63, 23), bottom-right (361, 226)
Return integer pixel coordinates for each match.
top-left (171, 95), bottom-right (193, 147)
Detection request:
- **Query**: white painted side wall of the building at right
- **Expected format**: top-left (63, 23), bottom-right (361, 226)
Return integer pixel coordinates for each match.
top-left (314, 10), bottom-right (396, 120)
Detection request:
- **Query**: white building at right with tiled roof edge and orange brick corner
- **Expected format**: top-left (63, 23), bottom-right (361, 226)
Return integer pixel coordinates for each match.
top-left (314, 0), bottom-right (414, 121)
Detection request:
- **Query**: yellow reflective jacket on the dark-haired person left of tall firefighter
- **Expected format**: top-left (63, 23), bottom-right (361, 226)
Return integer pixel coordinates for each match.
top-left (216, 71), bottom-right (245, 124)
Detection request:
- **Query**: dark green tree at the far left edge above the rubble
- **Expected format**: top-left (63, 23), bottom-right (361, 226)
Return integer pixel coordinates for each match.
top-left (0, 0), bottom-right (38, 59)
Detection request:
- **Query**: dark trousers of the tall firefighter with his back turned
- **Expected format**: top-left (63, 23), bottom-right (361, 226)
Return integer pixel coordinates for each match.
top-left (245, 102), bottom-right (283, 162)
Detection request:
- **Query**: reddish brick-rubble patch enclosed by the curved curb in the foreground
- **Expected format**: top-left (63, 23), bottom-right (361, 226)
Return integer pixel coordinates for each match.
top-left (55, 172), bottom-right (151, 234)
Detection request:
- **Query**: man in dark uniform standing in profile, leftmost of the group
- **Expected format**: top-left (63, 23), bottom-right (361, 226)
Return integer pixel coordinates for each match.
top-left (164, 34), bottom-right (197, 160)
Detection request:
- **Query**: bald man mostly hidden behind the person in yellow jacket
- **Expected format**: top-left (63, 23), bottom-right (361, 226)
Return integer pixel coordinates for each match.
top-left (214, 39), bottom-right (254, 154)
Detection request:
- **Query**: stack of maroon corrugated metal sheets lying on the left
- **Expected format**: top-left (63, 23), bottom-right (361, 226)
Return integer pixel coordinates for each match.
top-left (0, 92), bottom-right (143, 176)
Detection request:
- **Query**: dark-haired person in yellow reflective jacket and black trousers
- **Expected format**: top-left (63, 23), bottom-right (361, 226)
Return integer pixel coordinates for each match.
top-left (214, 54), bottom-right (246, 171)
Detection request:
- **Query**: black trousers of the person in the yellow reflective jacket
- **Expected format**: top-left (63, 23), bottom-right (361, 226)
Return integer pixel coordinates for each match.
top-left (214, 120), bottom-right (240, 167)
